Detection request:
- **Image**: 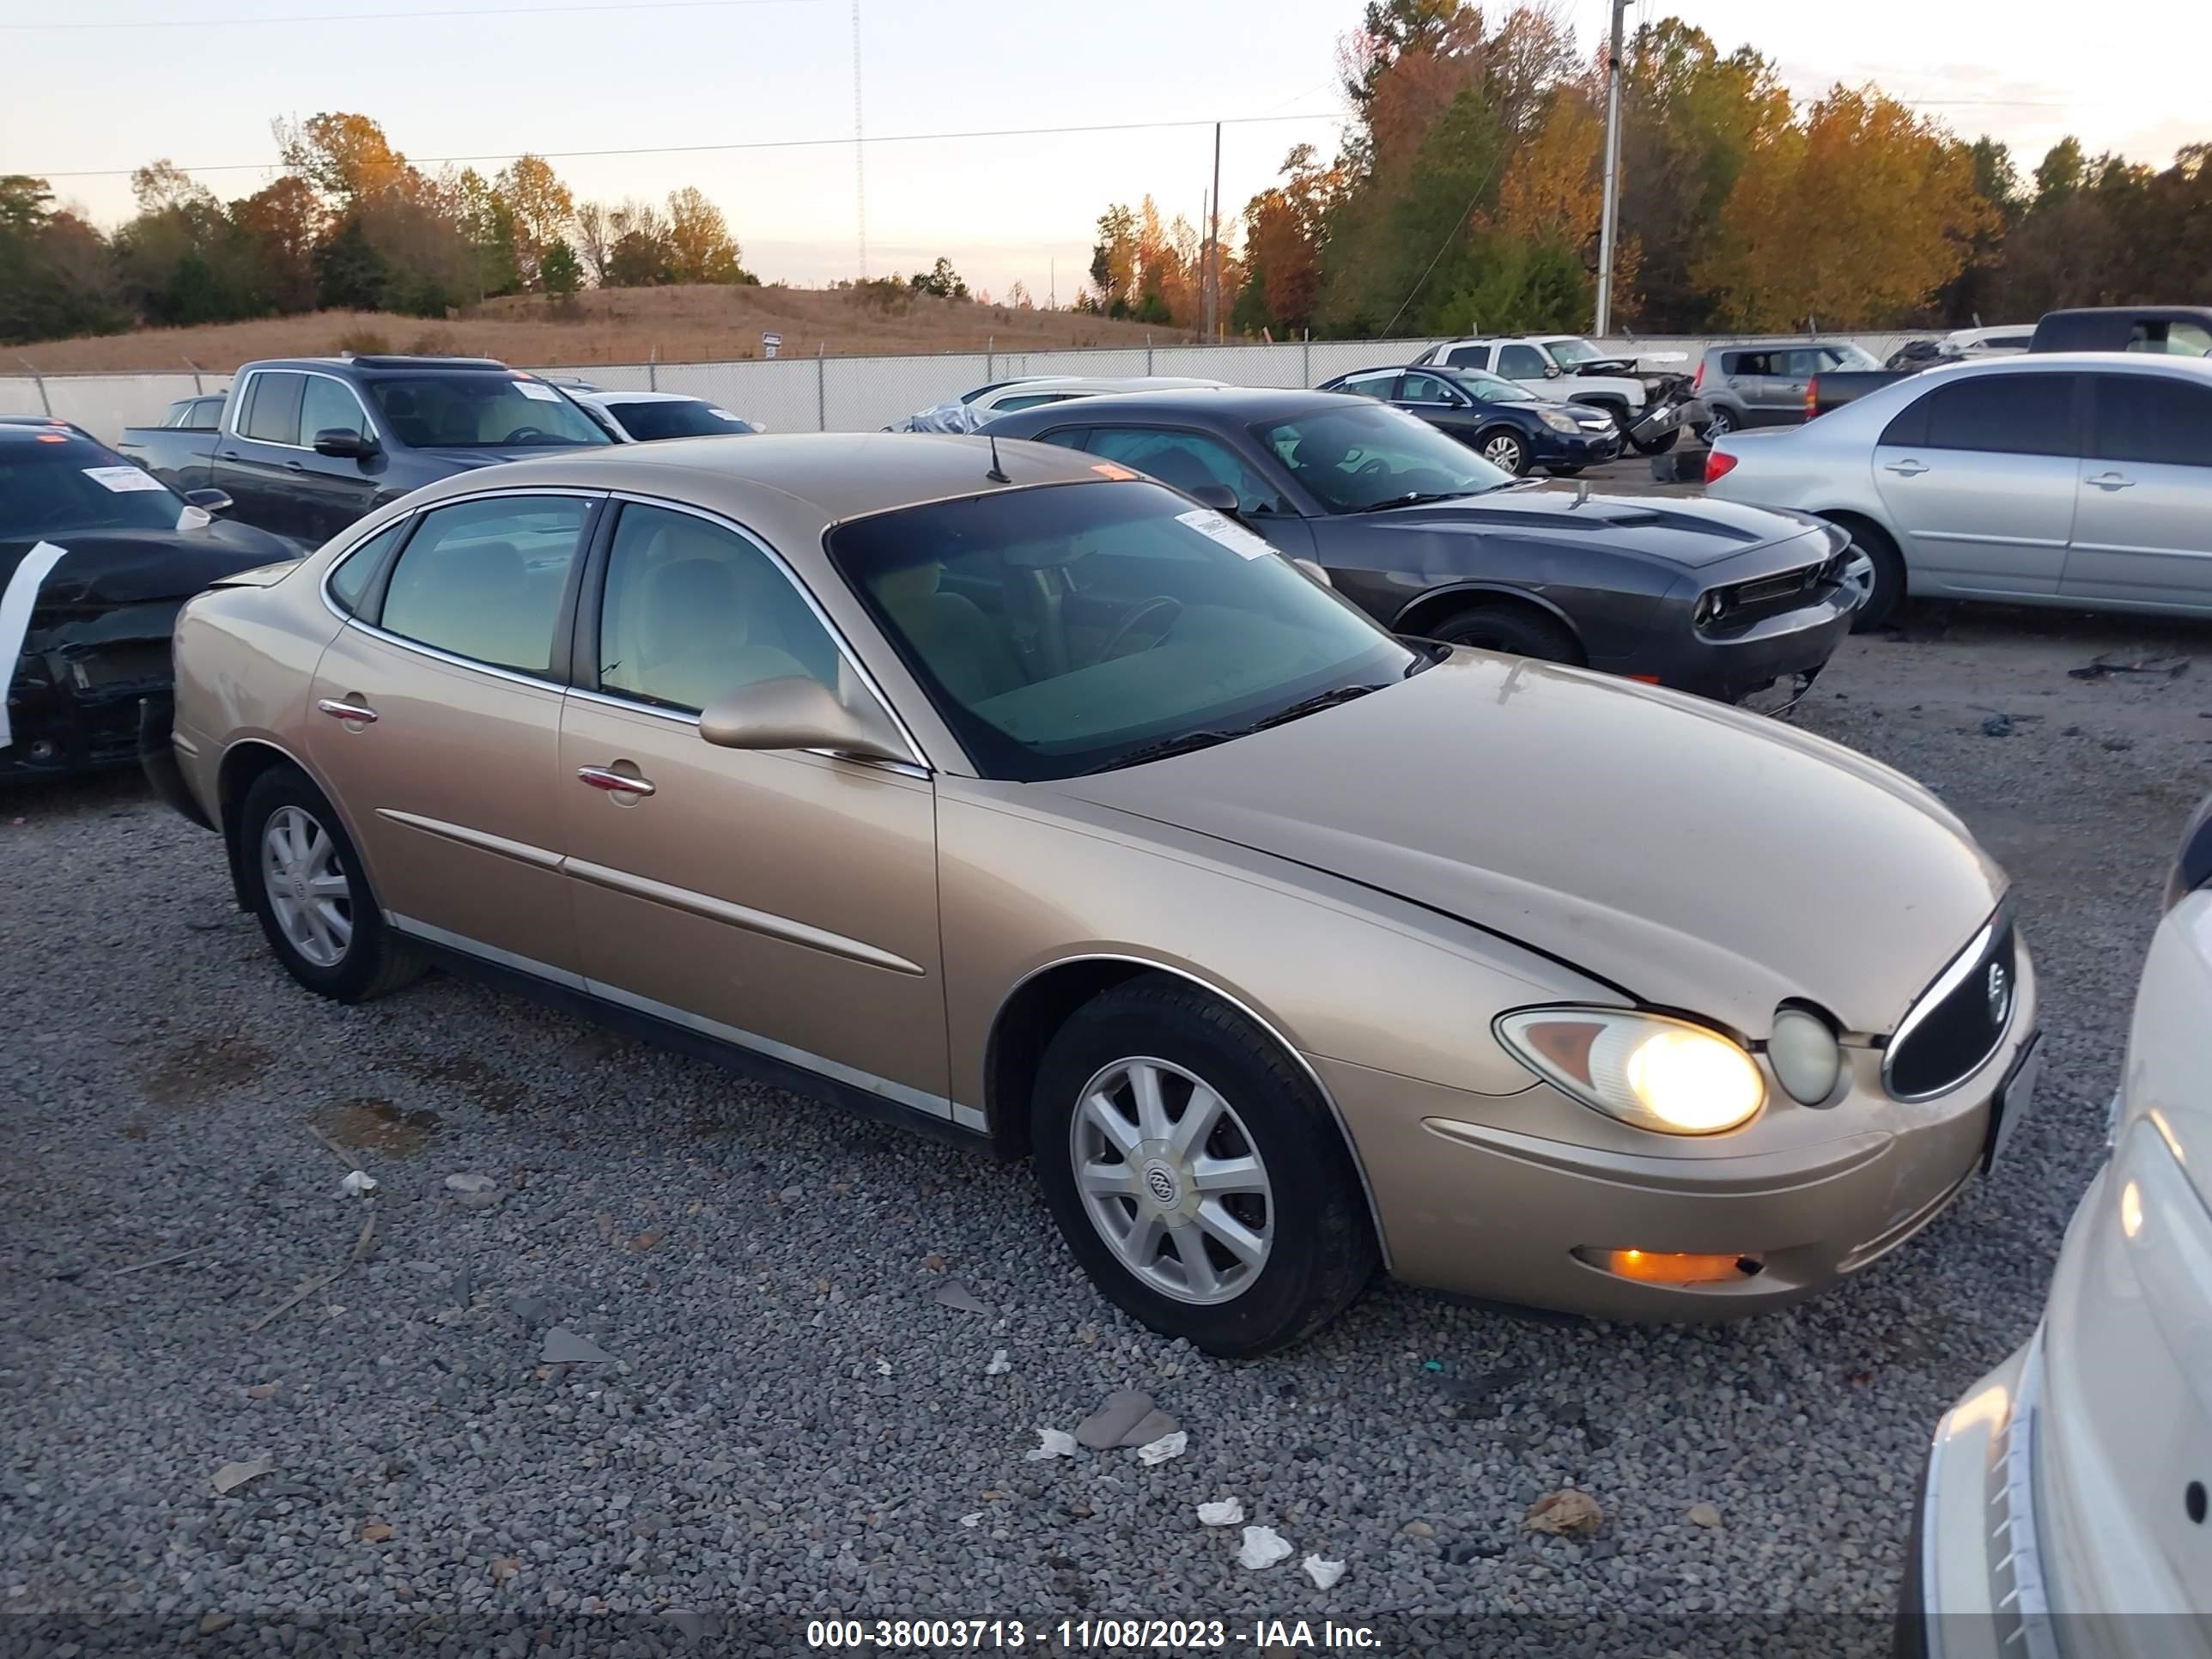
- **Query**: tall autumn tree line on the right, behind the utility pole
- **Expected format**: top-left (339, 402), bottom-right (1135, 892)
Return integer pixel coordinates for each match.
top-left (1078, 0), bottom-right (2212, 338)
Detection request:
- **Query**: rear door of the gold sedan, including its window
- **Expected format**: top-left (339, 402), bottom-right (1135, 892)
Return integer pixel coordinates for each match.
top-left (307, 489), bottom-right (604, 984)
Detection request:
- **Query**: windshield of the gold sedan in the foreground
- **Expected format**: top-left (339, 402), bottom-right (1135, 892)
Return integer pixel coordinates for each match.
top-left (827, 480), bottom-right (1427, 783)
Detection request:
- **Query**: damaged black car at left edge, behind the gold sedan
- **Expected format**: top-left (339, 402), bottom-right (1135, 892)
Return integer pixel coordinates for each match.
top-left (0, 422), bottom-right (295, 776)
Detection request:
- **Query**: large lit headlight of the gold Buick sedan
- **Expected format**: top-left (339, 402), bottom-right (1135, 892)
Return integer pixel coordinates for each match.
top-left (1498, 1009), bottom-right (1767, 1134)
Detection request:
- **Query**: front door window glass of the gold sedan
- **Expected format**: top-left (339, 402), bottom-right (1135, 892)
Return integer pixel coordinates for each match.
top-left (599, 504), bottom-right (838, 712)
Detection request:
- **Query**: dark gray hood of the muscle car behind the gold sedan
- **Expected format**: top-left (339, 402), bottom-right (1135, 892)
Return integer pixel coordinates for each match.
top-left (1364, 487), bottom-right (1812, 571)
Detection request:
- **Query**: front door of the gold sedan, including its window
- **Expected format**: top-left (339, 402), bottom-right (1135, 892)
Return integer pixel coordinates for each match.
top-left (556, 500), bottom-right (951, 1117)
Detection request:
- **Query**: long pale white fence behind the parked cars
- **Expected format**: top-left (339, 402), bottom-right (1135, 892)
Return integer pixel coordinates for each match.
top-left (0, 334), bottom-right (1924, 442)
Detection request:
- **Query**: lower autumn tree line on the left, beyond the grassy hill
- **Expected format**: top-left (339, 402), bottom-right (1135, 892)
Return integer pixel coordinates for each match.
top-left (0, 112), bottom-right (759, 343)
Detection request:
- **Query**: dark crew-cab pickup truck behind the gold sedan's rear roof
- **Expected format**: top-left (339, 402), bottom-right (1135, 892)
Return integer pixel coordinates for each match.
top-left (118, 356), bottom-right (613, 550)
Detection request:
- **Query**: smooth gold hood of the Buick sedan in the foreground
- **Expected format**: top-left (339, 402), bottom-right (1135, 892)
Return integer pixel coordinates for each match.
top-left (1048, 650), bottom-right (2006, 1037)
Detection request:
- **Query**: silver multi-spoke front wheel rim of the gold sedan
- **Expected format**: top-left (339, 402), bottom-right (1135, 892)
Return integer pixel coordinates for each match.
top-left (1068, 1057), bottom-right (1274, 1303)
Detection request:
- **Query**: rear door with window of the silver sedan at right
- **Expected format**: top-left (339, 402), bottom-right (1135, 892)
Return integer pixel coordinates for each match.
top-left (1874, 369), bottom-right (2081, 598)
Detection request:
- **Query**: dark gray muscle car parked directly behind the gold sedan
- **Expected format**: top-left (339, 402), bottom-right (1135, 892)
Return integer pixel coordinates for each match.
top-left (984, 389), bottom-right (1863, 703)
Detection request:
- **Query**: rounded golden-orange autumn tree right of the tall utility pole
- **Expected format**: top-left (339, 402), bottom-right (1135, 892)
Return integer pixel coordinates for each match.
top-left (1694, 86), bottom-right (1996, 330)
